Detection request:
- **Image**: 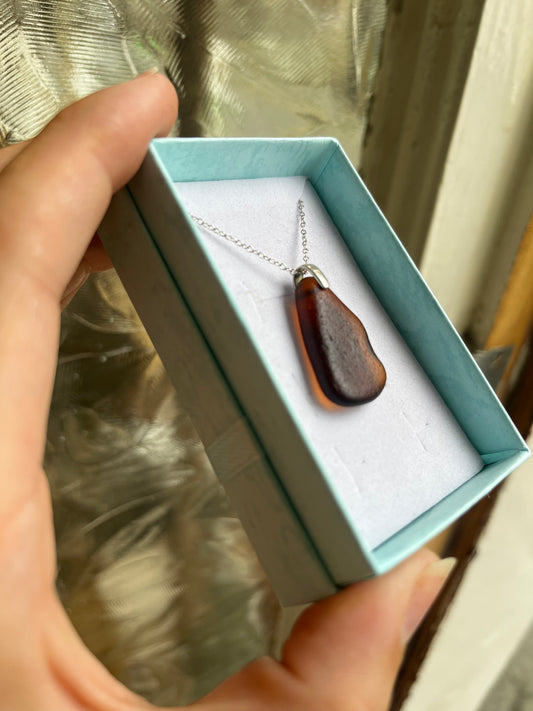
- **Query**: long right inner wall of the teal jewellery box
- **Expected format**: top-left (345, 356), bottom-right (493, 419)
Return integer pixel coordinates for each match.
top-left (315, 146), bottom-right (524, 460)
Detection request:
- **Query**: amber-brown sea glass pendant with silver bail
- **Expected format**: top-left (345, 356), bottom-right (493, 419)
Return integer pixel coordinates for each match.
top-left (294, 264), bottom-right (387, 407)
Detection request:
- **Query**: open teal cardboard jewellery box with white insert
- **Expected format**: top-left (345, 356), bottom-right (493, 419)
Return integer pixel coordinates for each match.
top-left (99, 138), bottom-right (529, 605)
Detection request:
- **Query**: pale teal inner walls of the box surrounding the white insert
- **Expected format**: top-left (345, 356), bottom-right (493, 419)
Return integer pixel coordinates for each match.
top-left (135, 138), bottom-right (528, 582)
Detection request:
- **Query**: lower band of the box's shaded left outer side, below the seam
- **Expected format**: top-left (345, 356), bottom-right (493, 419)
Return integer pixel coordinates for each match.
top-left (98, 188), bottom-right (337, 605)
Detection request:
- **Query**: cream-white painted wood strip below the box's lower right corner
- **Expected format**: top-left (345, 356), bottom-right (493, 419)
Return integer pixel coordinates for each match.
top-left (402, 437), bottom-right (533, 711)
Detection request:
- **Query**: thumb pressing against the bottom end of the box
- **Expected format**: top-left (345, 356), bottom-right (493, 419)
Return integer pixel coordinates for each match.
top-left (281, 550), bottom-right (455, 710)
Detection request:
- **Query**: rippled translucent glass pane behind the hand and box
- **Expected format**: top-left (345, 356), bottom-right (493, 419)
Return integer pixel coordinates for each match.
top-left (0, 0), bottom-right (386, 705)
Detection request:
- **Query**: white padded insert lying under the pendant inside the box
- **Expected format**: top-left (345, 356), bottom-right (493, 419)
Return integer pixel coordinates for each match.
top-left (176, 176), bottom-right (483, 547)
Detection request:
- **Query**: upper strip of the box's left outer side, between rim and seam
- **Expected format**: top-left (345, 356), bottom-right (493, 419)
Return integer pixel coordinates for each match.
top-left (129, 139), bottom-right (373, 584)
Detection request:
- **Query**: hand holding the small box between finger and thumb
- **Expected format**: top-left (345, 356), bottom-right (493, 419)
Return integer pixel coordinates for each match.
top-left (0, 74), bottom-right (449, 711)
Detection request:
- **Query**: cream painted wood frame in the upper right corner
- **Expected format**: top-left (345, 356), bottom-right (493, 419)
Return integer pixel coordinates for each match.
top-left (421, 0), bottom-right (533, 331)
